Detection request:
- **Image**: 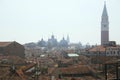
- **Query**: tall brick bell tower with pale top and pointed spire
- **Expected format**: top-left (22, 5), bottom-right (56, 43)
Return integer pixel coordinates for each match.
top-left (101, 3), bottom-right (109, 45)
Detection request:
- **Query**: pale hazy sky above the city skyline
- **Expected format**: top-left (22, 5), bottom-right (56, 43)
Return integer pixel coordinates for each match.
top-left (0, 0), bottom-right (120, 45)
